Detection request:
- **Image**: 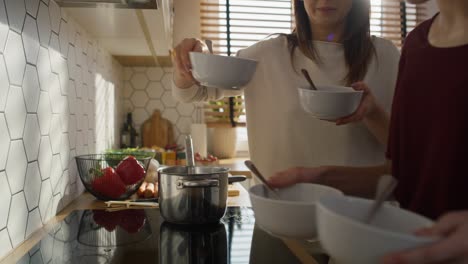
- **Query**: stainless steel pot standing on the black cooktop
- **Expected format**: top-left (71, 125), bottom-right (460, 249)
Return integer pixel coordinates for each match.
top-left (159, 166), bottom-right (245, 224)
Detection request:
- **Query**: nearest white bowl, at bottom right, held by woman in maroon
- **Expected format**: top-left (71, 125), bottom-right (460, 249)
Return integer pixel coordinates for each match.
top-left (317, 196), bottom-right (434, 264)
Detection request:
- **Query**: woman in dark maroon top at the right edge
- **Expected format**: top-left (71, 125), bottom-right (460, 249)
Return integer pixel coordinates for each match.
top-left (270, 0), bottom-right (468, 264)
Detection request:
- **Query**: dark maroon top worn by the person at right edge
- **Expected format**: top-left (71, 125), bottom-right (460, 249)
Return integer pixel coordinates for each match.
top-left (387, 15), bottom-right (468, 219)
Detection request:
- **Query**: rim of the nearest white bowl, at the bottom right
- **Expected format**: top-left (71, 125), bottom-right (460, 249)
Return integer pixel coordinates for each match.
top-left (317, 195), bottom-right (436, 243)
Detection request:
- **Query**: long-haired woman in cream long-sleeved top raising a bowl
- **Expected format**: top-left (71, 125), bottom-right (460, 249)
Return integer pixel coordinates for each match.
top-left (172, 0), bottom-right (399, 182)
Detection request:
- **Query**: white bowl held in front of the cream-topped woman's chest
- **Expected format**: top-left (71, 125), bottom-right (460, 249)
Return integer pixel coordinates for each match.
top-left (298, 85), bottom-right (362, 120)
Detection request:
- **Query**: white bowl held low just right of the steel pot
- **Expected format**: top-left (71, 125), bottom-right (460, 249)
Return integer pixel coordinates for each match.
top-left (249, 183), bottom-right (342, 239)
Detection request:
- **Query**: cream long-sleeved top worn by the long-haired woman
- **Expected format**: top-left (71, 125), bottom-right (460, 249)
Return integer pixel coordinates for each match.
top-left (173, 36), bottom-right (400, 177)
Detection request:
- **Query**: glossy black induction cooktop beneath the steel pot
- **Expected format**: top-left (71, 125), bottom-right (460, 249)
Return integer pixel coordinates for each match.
top-left (18, 207), bottom-right (327, 264)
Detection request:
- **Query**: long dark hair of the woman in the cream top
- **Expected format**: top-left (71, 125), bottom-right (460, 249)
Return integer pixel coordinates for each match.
top-left (286, 0), bottom-right (375, 85)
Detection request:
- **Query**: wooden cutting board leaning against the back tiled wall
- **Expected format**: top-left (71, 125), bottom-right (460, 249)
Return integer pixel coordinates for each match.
top-left (141, 110), bottom-right (175, 148)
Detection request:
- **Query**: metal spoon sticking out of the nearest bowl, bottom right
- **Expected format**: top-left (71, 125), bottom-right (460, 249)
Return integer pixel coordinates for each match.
top-left (364, 175), bottom-right (398, 224)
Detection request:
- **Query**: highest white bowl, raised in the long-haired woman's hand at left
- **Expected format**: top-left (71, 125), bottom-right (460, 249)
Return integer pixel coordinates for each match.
top-left (189, 52), bottom-right (257, 89)
